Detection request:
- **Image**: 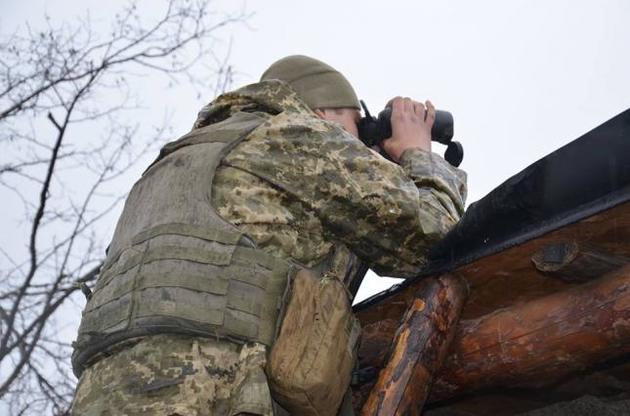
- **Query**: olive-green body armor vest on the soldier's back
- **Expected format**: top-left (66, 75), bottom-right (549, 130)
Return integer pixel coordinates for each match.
top-left (72, 113), bottom-right (293, 376)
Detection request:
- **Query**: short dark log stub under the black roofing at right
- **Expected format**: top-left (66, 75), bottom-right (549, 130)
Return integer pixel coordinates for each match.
top-left (532, 241), bottom-right (630, 283)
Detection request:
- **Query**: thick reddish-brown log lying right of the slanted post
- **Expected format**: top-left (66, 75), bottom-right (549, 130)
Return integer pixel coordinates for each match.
top-left (431, 266), bottom-right (630, 401)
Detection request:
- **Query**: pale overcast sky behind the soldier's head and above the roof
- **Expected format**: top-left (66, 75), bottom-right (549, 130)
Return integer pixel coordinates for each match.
top-left (0, 0), bottom-right (630, 298)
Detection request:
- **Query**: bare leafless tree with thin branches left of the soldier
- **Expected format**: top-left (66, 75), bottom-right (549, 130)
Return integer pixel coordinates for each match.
top-left (0, 0), bottom-right (248, 415)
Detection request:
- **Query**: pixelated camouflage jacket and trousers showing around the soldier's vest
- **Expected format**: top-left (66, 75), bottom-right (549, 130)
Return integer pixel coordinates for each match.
top-left (73, 81), bottom-right (466, 415)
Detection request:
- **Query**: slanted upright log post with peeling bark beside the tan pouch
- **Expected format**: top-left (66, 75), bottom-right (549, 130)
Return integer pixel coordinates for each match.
top-left (361, 275), bottom-right (468, 416)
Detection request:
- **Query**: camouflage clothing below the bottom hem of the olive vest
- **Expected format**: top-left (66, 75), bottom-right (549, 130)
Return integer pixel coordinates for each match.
top-left (71, 335), bottom-right (287, 416)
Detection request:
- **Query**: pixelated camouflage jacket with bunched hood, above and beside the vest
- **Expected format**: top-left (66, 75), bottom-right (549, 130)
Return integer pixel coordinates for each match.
top-left (205, 81), bottom-right (466, 277)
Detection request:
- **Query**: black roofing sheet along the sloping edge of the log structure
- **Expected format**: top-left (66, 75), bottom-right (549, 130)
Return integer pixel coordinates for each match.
top-left (355, 109), bottom-right (630, 309)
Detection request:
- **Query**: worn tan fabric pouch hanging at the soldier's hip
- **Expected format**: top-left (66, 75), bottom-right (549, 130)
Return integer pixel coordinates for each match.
top-left (267, 269), bottom-right (361, 416)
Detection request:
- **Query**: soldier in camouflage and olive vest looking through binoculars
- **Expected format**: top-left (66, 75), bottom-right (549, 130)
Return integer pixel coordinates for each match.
top-left (72, 56), bottom-right (466, 416)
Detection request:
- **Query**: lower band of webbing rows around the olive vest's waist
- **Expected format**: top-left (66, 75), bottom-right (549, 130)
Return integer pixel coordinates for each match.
top-left (73, 229), bottom-right (289, 368)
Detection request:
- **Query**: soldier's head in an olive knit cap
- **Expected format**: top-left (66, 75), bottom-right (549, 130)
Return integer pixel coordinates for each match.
top-left (260, 55), bottom-right (361, 137)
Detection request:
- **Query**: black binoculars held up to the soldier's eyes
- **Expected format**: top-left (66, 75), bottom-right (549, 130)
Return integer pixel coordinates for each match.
top-left (358, 100), bottom-right (464, 167)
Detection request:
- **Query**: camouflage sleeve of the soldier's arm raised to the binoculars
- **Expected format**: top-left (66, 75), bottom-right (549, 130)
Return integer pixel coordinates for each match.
top-left (223, 112), bottom-right (466, 277)
